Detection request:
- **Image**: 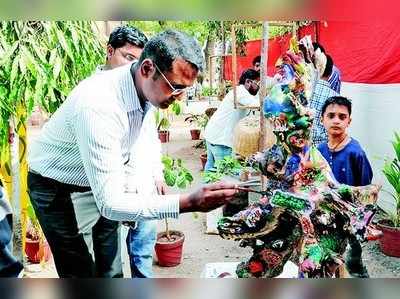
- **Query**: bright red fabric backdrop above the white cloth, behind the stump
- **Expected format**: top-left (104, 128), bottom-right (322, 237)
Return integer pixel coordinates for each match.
top-left (225, 20), bottom-right (400, 84)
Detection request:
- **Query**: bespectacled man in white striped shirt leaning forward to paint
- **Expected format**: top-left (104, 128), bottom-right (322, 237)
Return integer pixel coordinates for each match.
top-left (28, 30), bottom-right (241, 277)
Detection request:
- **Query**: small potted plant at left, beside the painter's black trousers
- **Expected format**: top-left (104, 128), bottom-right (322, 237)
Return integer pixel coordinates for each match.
top-left (25, 203), bottom-right (51, 264)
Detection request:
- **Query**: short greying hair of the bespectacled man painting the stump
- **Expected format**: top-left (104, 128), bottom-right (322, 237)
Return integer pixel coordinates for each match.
top-left (138, 29), bottom-right (204, 72)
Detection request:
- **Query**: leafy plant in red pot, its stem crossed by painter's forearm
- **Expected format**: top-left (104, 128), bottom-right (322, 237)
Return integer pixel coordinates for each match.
top-left (155, 156), bottom-right (193, 267)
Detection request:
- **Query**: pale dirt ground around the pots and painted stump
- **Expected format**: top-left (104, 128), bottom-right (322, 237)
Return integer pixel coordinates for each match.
top-left (26, 117), bottom-right (400, 278)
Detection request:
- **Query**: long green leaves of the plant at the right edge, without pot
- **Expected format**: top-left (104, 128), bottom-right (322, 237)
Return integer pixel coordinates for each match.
top-left (382, 132), bottom-right (400, 227)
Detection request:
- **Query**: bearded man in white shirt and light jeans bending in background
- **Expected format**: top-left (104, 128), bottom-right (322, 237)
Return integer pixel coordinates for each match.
top-left (204, 69), bottom-right (260, 171)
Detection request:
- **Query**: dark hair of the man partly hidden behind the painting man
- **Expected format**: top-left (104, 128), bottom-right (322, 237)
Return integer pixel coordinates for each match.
top-left (107, 26), bottom-right (147, 49)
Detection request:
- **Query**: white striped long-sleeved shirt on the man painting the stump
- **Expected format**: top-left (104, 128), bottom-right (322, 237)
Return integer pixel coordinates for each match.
top-left (29, 65), bottom-right (179, 221)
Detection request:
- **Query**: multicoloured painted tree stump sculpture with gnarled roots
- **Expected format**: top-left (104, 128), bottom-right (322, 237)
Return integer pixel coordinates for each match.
top-left (218, 39), bottom-right (380, 278)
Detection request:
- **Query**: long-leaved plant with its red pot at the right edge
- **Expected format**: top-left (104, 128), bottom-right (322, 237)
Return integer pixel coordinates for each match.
top-left (377, 133), bottom-right (400, 257)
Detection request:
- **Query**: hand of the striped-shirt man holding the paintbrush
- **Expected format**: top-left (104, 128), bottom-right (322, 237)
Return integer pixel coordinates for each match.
top-left (179, 183), bottom-right (238, 213)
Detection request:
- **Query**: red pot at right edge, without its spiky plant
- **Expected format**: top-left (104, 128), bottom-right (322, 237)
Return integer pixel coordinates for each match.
top-left (377, 220), bottom-right (400, 257)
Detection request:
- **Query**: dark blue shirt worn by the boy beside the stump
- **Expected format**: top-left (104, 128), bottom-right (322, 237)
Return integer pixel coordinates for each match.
top-left (318, 138), bottom-right (373, 186)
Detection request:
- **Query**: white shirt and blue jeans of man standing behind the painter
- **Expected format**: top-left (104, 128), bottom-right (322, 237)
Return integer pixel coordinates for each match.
top-left (122, 107), bottom-right (166, 278)
